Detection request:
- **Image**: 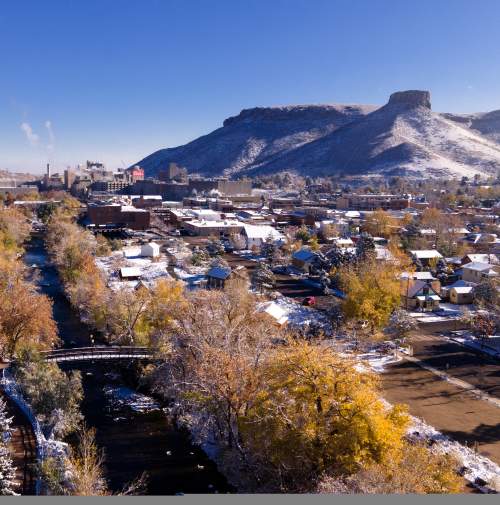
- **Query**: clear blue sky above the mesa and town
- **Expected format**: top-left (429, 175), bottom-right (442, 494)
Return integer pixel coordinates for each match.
top-left (0, 0), bottom-right (500, 172)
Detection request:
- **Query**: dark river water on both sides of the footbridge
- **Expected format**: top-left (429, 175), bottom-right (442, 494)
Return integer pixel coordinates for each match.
top-left (24, 237), bottom-right (231, 495)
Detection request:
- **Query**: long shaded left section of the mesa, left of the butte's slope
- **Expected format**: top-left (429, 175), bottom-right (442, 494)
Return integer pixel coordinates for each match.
top-left (133, 105), bottom-right (375, 175)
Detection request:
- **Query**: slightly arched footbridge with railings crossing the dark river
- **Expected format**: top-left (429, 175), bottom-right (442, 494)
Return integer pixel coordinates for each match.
top-left (41, 346), bottom-right (155, 363)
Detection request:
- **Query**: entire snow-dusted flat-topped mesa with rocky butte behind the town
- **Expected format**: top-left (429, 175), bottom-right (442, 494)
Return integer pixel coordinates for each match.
top-left (138, 90), bottom-right (500, 178)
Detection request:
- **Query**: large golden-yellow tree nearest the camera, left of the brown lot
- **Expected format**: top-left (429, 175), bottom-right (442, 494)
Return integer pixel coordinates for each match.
top-left (240, 342), bottom-right (408, 491)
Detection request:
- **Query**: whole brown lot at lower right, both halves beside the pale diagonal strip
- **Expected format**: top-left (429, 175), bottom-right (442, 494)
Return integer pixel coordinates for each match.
top-left (382, 328), bottom-right (500, 464)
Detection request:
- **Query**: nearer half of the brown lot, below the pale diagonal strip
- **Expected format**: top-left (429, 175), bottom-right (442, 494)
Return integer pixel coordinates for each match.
top-left (381, 361), bottom-right (500, 464)
